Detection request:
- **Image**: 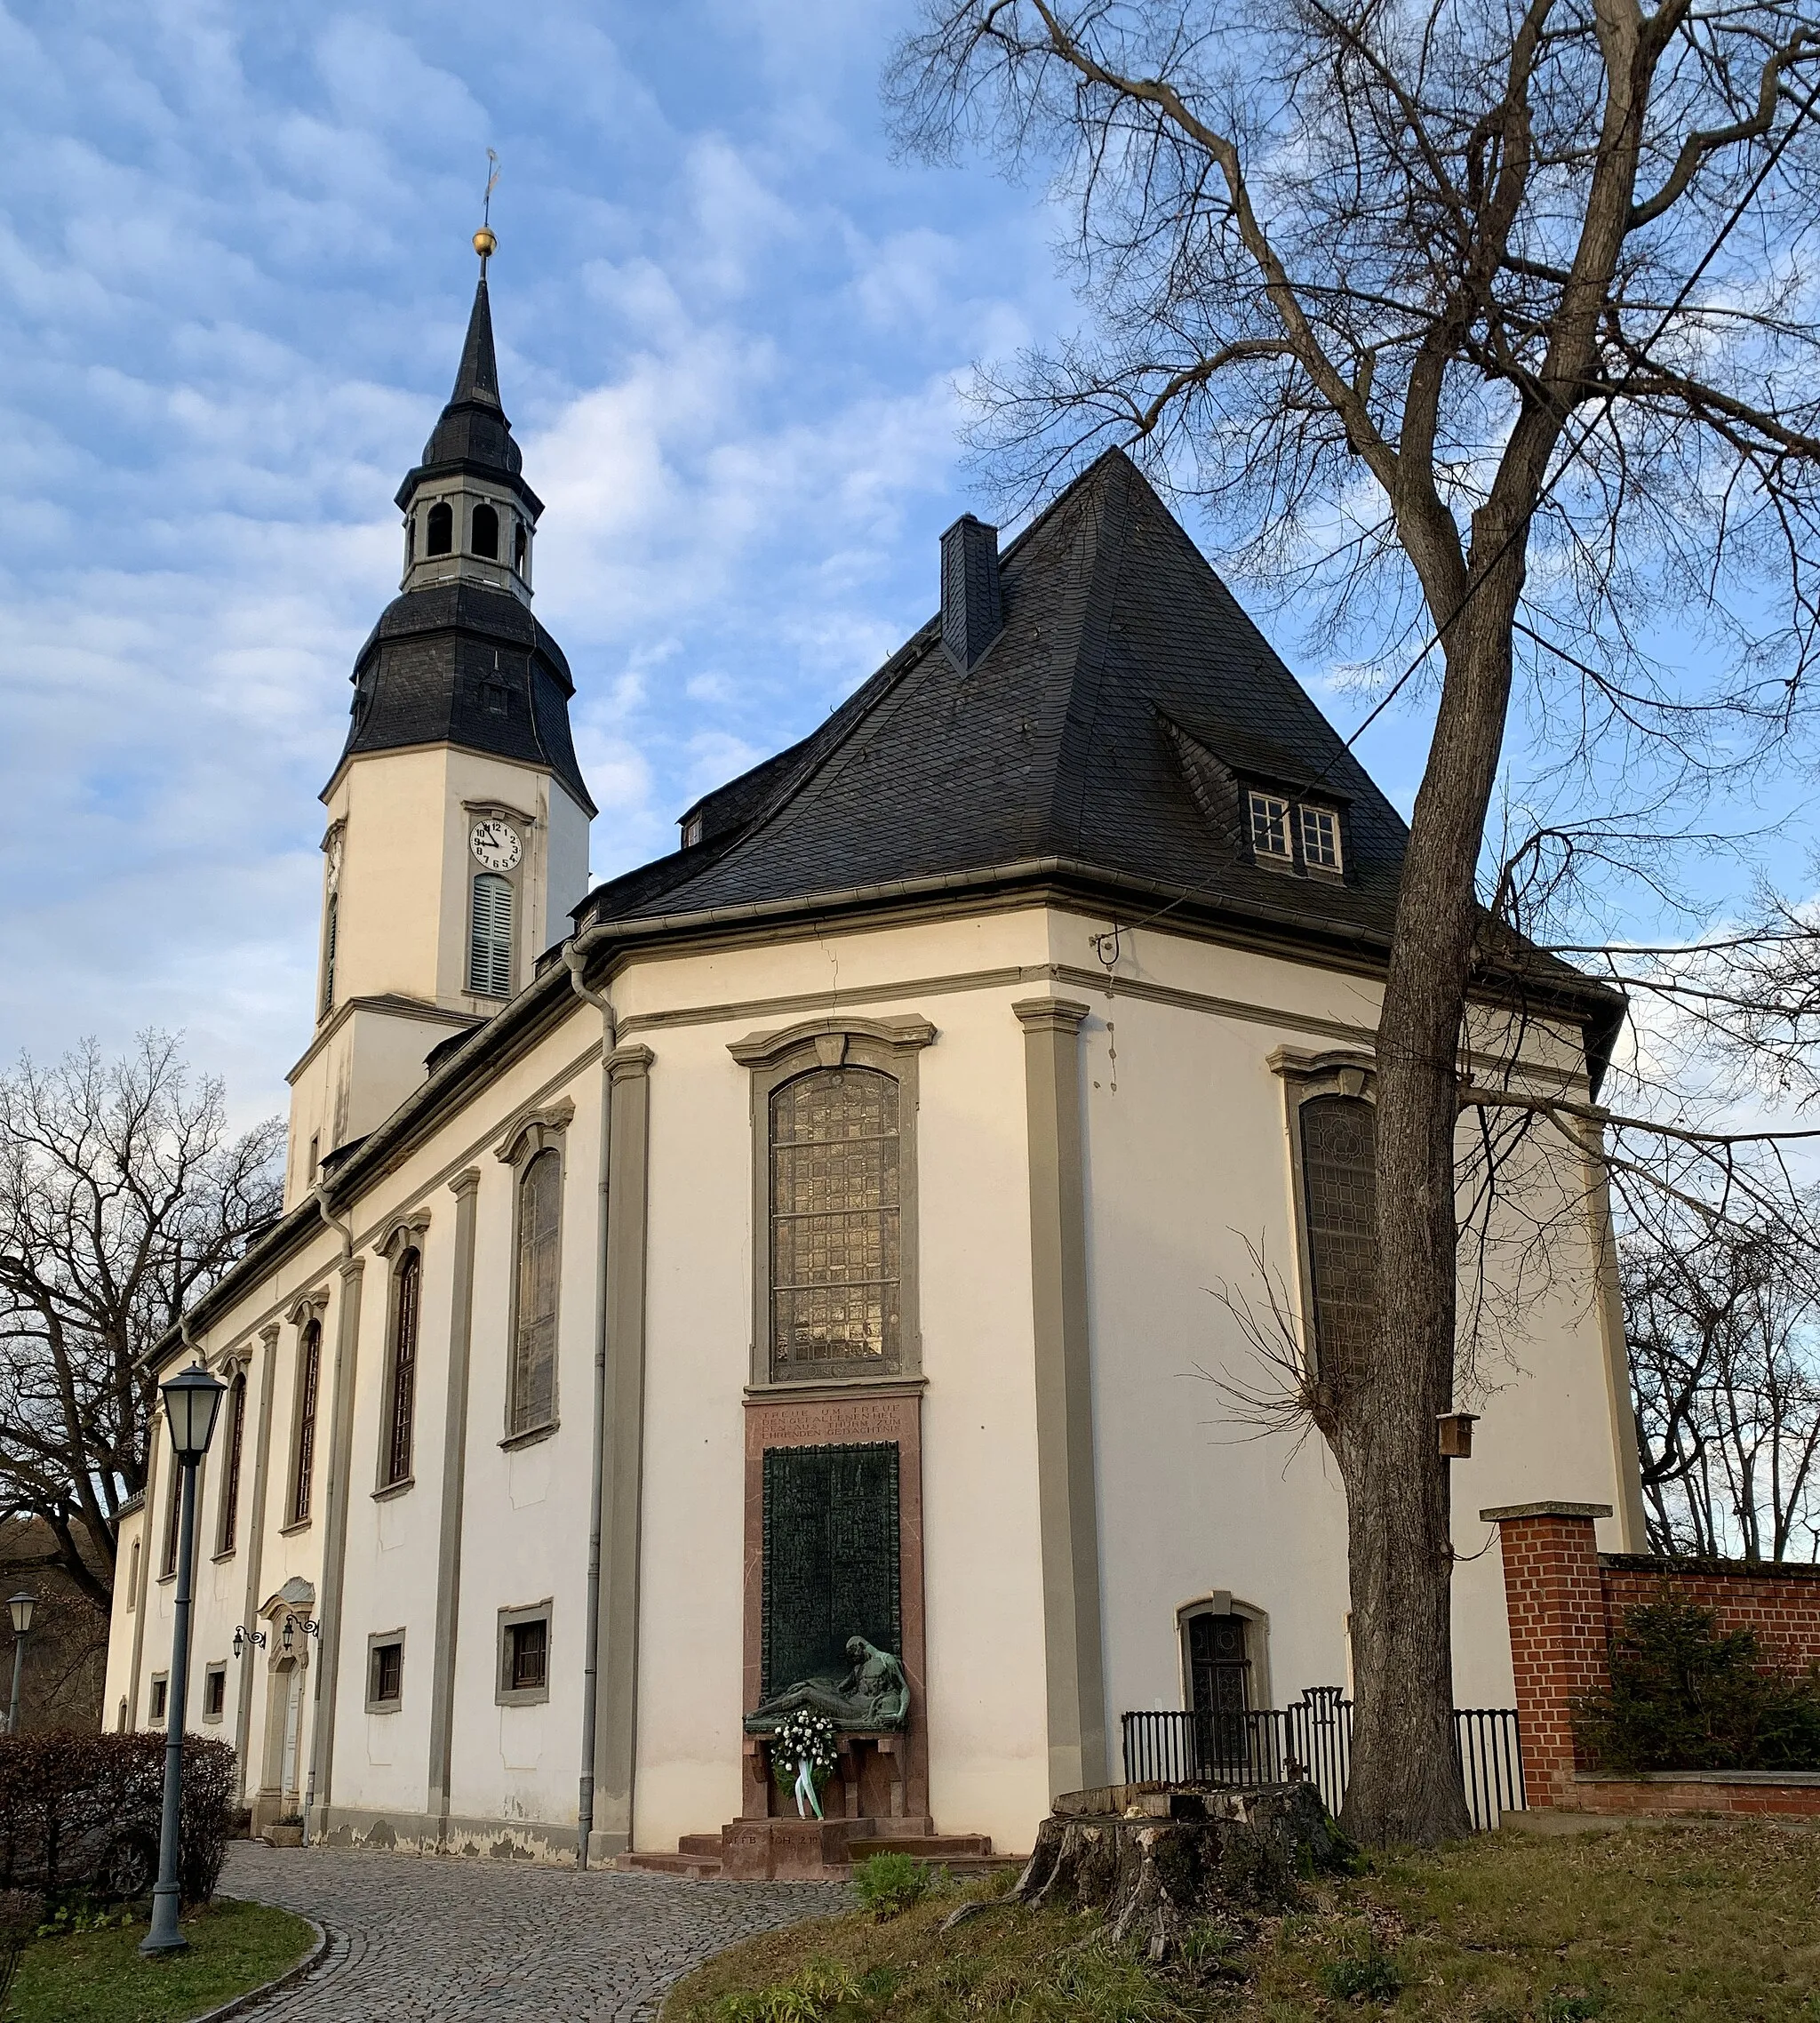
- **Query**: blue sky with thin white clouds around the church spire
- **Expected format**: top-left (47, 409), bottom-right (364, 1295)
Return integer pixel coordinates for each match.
top-left (0, 0), bottom-right (1811, 1119)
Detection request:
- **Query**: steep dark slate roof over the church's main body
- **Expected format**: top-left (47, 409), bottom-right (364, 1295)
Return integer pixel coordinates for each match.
top-left (577, 452), bottom-right (1622, 1051)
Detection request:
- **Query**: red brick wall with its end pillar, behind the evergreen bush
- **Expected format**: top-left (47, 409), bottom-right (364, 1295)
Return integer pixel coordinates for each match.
top-left (1481, 1503), bottom-right (1820, 1811)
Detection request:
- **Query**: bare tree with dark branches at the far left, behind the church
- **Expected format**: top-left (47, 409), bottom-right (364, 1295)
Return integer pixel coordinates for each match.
top-left (0, 1032), bottom-right (283, 1608)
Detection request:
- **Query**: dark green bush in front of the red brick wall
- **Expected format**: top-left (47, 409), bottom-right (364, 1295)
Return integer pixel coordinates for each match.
top-left (1573, 1592), bottom-right (1820, 1772)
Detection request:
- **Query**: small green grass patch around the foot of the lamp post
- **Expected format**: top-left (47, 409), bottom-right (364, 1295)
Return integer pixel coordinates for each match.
top-left (0, 1898), bottom-right (315, 2023)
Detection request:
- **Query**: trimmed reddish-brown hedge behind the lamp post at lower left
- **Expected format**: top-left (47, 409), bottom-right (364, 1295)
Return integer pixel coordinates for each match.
top-left (0, 1731), bottom-right (235, 1904)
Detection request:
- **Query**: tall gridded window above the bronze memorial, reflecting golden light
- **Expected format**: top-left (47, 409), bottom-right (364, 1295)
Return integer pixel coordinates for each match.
top-left (770, 1068), bottom-right (900, 1376)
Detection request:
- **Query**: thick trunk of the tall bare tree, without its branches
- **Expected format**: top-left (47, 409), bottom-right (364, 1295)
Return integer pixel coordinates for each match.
top-left (1335, 562), bottom-right (1522, 1845)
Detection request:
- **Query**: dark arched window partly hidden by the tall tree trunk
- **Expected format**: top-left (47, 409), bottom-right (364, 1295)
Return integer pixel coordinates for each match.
top-left (1300, 1097), bottom-right (1377, 1386)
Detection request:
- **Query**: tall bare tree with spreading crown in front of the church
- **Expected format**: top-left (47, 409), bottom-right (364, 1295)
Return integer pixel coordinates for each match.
top-left (888, 0), bottom-right (1820, 1841)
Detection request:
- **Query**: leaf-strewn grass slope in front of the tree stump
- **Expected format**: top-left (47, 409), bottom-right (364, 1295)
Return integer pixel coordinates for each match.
top-left (663, 1825), bottom-right (1820, 2023)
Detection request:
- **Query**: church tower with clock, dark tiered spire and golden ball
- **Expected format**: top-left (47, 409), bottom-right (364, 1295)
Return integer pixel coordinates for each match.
top-left (285, 228), bottom-right (595, 1205)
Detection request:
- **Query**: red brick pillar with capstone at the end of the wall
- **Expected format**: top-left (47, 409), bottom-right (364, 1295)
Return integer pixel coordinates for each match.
top-left (1478, 1503), bottom-right (1612, 1811)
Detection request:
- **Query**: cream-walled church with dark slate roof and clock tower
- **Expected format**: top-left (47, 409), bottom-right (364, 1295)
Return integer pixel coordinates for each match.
top-left (108, 235), bottom-right (1644, 1874)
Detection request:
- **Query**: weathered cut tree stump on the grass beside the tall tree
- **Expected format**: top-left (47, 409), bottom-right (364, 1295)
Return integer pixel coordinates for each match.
top-left (1011, 1784), bottom-right (1349, 1960)
